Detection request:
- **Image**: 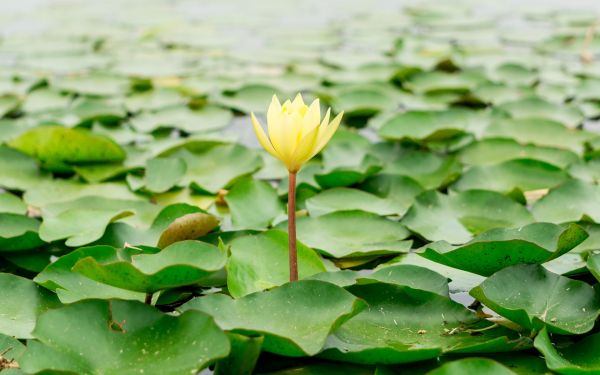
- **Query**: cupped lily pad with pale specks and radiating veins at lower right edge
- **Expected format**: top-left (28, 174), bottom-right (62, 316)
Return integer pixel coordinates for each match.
top-left (471, 264), bottom-right (600, 335)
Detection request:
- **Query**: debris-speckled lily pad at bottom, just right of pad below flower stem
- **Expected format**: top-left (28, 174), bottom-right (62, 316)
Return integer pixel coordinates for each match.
top-left (321, 283), bottom-right (530, 364)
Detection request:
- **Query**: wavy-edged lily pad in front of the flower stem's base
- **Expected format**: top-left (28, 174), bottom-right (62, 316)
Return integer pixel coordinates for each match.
top-left (180, 280), bottom-right (364, 357)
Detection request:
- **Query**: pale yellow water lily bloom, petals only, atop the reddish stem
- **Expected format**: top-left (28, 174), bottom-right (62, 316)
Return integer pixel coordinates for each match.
top-left (251, 94), bottom-right (344, 173)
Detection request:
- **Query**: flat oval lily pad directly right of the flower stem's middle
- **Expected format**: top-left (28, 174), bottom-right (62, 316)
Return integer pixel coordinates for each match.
top-left (280, 211), bottom-right (412, 258)
